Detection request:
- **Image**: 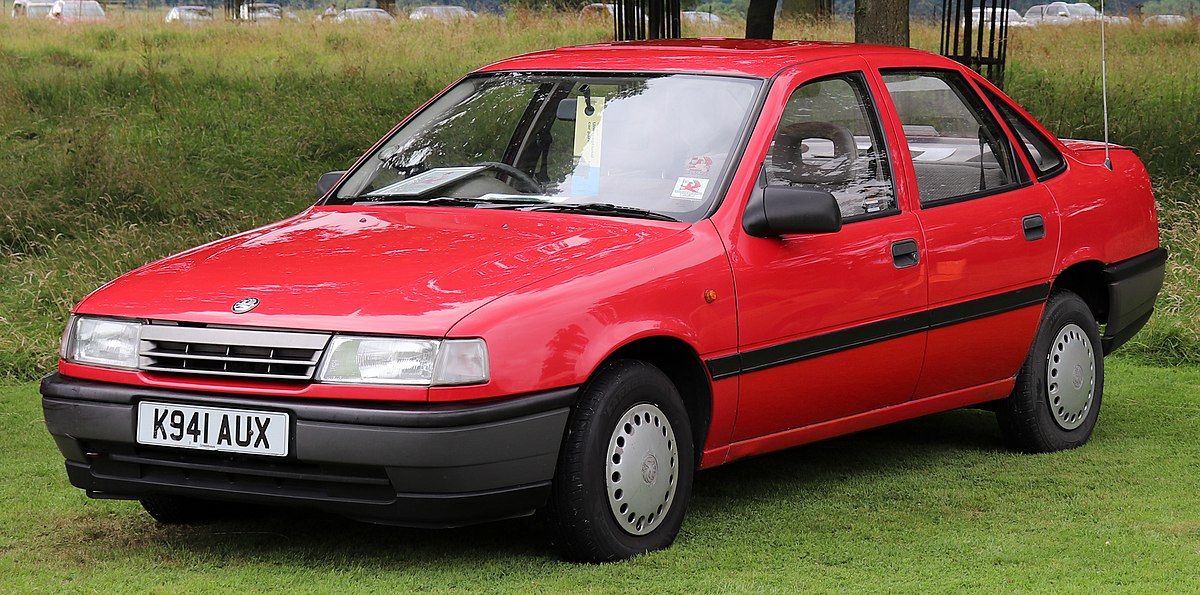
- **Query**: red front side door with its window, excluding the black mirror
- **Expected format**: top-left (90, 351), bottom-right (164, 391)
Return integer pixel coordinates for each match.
top-left (731, 58), bottom-right (926, 441)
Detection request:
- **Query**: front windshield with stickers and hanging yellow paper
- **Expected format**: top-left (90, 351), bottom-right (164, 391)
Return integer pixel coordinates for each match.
top-left (330, 73), bottom-right (761, 221)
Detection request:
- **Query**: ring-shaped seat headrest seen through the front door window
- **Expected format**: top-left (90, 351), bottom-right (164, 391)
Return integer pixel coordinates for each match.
top-left (770, 122), bottom-right (858, 184)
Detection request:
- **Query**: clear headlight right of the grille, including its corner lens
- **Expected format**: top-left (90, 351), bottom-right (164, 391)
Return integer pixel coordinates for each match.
top-left (317, 336), bottom-right (488, 386)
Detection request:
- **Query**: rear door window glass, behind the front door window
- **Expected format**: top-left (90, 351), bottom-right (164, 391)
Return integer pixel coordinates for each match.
top-left (883, 71), bottom-right (1022, 206)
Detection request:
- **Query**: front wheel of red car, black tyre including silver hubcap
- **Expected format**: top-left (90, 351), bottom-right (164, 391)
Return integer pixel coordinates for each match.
top-left (545, 360), bottom-right (695, 563)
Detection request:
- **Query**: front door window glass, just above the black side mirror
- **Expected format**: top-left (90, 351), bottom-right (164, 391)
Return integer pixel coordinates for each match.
top-left (766, 73), bottom-right (896, 222)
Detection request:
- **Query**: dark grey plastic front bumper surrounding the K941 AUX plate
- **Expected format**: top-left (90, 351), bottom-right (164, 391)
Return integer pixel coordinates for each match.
top-left (41, 373), bottom-right (577, 527)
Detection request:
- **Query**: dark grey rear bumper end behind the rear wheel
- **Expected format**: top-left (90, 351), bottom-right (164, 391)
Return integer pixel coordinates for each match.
top-left (1100, 248), bottom-right (1168, 355)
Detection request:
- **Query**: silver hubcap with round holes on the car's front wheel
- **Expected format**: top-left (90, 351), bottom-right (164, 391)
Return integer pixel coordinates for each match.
top-left (607, 403), bottom-right (679, 535)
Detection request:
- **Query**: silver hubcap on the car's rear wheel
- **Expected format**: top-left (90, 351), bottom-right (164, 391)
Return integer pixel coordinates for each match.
top-left (1046, 323), bottom-right (1096, 429)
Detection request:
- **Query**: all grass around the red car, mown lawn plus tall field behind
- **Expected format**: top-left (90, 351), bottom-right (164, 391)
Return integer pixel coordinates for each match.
top-left (0, 12), bottom-right (1200, 593)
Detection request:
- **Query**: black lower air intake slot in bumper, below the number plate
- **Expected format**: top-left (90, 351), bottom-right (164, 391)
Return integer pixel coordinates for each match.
top-left (83, 441), bottom-right (396, 504)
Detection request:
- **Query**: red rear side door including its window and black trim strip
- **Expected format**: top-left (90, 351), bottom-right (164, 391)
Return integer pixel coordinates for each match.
top-left (880, 59), bottom-right (1058, 398)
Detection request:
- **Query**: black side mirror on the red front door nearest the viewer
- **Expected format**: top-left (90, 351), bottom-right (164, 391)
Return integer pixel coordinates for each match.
top-left (742, 186), bottom-right (841, 238)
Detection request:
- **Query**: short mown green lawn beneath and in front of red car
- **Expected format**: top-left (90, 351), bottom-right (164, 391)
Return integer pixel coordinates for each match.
top-left (0, 359), bottom-right (1200, 593)
